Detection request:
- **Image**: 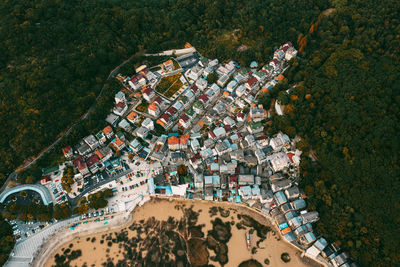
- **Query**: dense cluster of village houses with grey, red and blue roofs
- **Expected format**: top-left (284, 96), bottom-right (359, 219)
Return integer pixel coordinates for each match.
top-left (54, 42), bottom-right (351, 266)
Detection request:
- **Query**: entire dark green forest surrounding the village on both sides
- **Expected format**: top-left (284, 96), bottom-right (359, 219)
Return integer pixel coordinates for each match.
top-left (0, 0), bottom-right (400, 266)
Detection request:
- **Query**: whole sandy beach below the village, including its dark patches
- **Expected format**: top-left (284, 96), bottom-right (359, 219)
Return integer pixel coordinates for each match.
top-left (46, 199), bottom-right (320, 267)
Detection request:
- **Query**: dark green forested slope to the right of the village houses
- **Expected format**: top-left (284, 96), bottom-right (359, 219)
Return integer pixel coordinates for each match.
top-left (280, 1), bottom-right (400, 266)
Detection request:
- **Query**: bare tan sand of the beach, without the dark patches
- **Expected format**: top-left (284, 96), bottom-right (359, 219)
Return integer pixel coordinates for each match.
top-left (46, 199), bottom-right (319, 267)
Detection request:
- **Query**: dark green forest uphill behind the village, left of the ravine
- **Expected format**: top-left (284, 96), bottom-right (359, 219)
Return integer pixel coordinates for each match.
top-left (0, 0), bottom-right (328, 187)
